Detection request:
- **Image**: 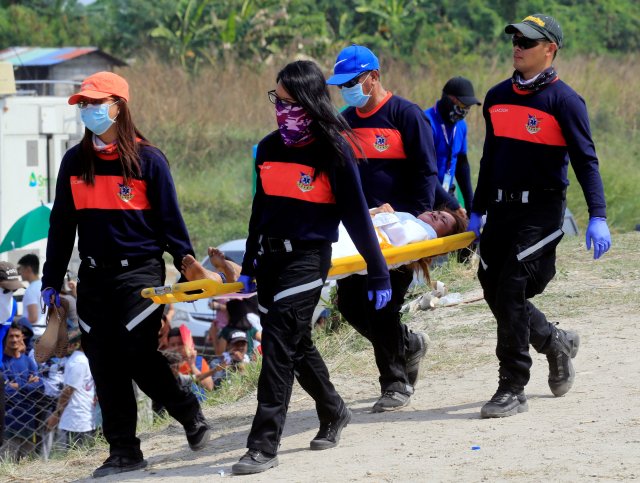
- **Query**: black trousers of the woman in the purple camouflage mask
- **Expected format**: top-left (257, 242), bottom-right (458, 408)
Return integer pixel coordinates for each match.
top-left (247, 243), bottom-right (344, 454)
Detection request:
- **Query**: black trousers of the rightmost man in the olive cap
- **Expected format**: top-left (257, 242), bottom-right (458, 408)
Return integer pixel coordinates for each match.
top-left (478, 200), bottom-right (565, 390)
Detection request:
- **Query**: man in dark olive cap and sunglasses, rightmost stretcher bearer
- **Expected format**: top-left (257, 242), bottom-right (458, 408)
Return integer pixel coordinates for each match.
top-left (469, 14), bottom-right (611, 418)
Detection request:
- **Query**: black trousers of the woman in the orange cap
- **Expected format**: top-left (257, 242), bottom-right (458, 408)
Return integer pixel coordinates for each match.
top-left (78, 260), bottom-right (200, 457)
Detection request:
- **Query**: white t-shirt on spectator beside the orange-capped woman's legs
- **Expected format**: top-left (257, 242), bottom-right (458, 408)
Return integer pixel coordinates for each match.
top-left (59, 350), bottom-right (96, 433)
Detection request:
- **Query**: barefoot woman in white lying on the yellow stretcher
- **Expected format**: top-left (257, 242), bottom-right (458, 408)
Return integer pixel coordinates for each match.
top-left (182, 203), bottom-right (467, 282)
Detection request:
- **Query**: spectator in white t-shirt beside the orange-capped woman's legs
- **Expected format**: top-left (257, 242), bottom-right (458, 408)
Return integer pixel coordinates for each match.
top-left (47, 330), bottom-right (96, 449)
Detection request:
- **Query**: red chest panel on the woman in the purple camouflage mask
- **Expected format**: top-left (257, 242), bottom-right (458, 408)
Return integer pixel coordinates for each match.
top-left (260, 161), bottom-right (336, 203)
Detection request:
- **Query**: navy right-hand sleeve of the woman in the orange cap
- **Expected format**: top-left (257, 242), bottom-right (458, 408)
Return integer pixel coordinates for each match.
top-left (143, 148), bottom-right (194, 272)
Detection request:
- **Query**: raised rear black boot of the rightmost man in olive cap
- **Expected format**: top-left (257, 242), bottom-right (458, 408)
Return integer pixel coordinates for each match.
top-left (547, 328), bottom-right (580, 397)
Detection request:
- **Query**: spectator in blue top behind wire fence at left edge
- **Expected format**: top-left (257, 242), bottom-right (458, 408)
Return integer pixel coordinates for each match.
top-left (2, 322), bottom-right (44, 459)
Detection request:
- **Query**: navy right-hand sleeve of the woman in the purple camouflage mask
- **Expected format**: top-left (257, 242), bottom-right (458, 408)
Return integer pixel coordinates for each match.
top-left (334, 149), bottom-right (391, 290)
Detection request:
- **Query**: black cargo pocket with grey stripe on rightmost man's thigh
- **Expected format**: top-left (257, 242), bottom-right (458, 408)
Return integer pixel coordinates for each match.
top-left (516, 229), bottom-right (564, 298)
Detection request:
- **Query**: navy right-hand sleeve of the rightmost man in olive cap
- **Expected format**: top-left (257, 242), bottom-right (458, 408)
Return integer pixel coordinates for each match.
top-left (558, 94), bottom-right (607, 218)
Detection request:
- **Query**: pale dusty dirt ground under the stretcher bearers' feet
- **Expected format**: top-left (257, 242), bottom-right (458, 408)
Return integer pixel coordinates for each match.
top-left (3, 233), bottom-right (640, 482)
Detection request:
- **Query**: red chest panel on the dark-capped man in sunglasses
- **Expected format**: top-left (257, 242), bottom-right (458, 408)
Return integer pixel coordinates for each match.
top-left (489, 104), bottom-right (567, 146)
